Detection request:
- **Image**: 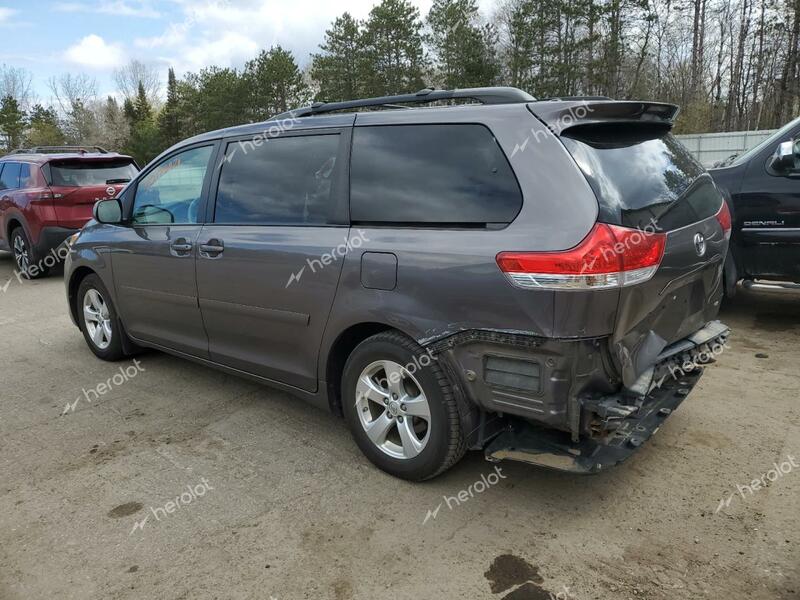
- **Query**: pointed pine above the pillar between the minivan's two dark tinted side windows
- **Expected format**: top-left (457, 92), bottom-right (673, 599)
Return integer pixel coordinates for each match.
top-left (311, 13), bottom-right (363, 102)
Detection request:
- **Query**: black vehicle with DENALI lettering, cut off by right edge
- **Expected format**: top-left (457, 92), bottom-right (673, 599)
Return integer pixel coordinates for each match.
top-left (709, 118), bottom-right (800, 296)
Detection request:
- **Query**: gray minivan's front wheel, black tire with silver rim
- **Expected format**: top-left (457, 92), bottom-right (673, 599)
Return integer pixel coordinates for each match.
top-left (75, 275), bottom-right (126, 361)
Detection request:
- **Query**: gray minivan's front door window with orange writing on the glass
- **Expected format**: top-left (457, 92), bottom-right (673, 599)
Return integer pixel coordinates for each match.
top-left (132, 146), bottom-right (214, 225)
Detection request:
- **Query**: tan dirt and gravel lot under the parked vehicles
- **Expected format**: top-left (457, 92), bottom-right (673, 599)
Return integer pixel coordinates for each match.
top-left (0, 253), bottom-right (800, 600)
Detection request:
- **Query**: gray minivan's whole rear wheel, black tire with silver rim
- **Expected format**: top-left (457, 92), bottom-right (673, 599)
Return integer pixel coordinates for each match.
top-left (342, 332), bottom-right (467, 481)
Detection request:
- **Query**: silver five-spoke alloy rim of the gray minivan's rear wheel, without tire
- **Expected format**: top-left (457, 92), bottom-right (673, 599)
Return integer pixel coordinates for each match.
top-left (355, 360), bottom-right (431, 460)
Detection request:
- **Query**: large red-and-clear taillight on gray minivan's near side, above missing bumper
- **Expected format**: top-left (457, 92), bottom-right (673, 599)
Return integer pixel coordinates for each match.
top-left (497, 223), bottom-right (667, 290)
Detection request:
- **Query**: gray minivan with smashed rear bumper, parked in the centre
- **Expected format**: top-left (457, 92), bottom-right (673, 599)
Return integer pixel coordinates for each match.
top-left (65, 88), bottom-right (730, 480)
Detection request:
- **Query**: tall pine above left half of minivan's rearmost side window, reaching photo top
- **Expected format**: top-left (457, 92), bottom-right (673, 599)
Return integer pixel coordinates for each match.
top-left (359, 0), bottom-right (426, 96)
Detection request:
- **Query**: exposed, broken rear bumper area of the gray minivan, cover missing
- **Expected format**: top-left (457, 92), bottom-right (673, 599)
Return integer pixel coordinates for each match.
top-left (437, 321), bottom-right (729, 473)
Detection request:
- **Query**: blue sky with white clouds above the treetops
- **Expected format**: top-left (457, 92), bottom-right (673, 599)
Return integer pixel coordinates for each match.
top-left (0, 0), bottom-right (494, 103)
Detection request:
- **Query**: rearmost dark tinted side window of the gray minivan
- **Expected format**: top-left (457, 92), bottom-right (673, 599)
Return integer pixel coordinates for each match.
top-left (350, 125), bottom-right (522, 225)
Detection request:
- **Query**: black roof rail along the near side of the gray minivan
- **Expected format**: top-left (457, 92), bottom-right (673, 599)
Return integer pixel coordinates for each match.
top-left (271, 87), bottom-right (536, 120)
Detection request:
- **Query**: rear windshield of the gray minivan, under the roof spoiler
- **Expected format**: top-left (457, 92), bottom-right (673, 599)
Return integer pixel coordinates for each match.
top-left (561, 124), bottom-right (722, 230)
